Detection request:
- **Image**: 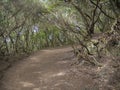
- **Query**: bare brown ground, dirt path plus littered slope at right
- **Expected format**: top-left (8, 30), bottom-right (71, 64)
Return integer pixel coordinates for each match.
top-left (0, 47), bottom-right (119, 90)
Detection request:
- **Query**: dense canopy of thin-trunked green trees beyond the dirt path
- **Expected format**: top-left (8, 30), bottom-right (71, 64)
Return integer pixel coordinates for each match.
top-left (0, 0), bottom-right (120, 62)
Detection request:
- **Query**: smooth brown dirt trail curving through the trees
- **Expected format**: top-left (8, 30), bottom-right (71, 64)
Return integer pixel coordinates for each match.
top-left (0, 47), bottom-right (98, 90)
